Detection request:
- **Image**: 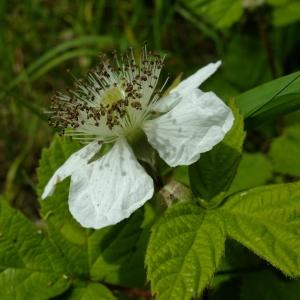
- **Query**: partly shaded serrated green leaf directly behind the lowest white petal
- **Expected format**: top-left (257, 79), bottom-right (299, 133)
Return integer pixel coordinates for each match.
top-left (38, 137), bottom-right (153, 287)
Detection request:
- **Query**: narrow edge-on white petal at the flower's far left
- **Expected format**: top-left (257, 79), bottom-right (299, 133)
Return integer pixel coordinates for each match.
top-left (42, 141), bottom-right (101, 199)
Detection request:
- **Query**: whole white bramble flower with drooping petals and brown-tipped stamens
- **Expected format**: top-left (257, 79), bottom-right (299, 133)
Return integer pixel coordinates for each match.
top-left (42, 48), bottom-right (233, 228)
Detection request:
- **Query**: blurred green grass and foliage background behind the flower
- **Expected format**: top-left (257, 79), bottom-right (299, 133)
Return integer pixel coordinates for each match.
top-left (0, 0), bottom-right (300, 217)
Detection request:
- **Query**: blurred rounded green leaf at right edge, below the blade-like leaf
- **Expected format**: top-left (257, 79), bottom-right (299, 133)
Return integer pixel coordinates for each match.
top-left (269, 124), bottom-right (300, 176)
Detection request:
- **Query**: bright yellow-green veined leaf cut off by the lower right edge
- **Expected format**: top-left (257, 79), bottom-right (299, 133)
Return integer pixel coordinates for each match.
top-left (219, 182), bottom-right (300, 276)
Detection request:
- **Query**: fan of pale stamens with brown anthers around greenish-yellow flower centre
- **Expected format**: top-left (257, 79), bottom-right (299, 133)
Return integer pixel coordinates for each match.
top-left (49, 46), bottom-right (164, 134)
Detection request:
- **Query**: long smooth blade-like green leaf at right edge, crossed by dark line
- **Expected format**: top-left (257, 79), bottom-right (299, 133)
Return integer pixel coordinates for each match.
top-left (236, 71), bottom-right (300, 124)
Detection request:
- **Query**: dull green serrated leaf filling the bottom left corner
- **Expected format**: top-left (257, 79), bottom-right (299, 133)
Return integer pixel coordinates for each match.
top-left (0, 201), bottom-right (70, 300)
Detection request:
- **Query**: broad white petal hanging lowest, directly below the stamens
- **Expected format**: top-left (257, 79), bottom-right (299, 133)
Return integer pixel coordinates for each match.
top-left (69, 140), bottom-right (154, 229)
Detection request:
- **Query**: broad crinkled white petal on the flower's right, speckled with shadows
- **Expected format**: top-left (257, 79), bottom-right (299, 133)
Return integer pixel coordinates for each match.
top-left (144, 89), bottom-right (234, 167)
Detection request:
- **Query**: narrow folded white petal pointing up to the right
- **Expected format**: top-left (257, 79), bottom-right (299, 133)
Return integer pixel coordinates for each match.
top-left (153, 61), bottom-right (221, 113)
